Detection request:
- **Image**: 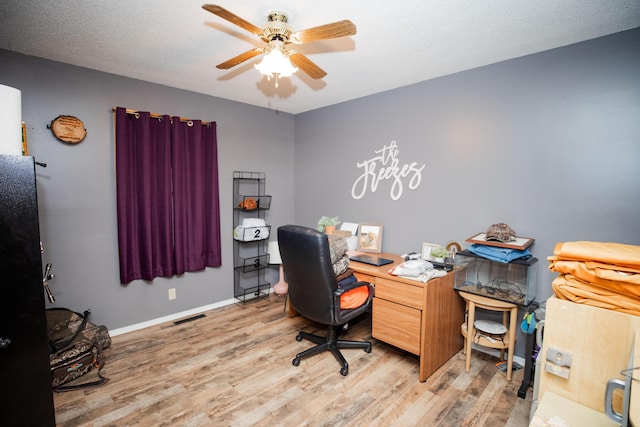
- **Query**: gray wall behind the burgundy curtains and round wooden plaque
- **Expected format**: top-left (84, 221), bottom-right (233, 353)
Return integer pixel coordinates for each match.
top-left (0, 50), bottom-right (294, 329)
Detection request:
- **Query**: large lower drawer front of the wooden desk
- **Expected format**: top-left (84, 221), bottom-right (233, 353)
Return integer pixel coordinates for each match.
top-left (371, 297), bottom-right (421, 355)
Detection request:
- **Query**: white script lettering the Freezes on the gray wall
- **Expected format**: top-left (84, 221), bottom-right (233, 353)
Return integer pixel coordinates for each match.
top-left (351, 141), bottom-right (426, 200)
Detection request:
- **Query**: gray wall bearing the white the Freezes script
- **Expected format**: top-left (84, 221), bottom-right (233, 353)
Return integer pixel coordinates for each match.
top-left (296, 25), bottom-right (640, 301)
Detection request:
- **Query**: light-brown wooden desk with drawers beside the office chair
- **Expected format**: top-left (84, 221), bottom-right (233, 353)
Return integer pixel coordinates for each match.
top-left (349, 253), bottom-right (464, 381)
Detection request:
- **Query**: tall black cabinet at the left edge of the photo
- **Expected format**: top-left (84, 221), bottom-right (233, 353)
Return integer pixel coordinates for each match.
top-left (0, 155), bottom-right (55, 426)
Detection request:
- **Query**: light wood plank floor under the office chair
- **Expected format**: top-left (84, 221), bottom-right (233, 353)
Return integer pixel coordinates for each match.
top-left (54, 296), bottom-right (532, 427)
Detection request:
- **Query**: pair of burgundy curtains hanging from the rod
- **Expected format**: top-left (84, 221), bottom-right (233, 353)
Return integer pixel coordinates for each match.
top-left (116, 107), bottom-right (221, 283)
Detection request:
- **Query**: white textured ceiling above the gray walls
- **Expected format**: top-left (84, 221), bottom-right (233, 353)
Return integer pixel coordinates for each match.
top-left (0, 0), bottom-right (640, 114)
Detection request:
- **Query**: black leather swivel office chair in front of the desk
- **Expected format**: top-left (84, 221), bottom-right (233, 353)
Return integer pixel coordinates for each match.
top-left (278, 225), bottom-right (374, 375)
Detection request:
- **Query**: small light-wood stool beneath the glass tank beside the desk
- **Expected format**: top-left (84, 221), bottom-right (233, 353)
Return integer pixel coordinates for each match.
top-left (458, 291), bottom-right (518, 381)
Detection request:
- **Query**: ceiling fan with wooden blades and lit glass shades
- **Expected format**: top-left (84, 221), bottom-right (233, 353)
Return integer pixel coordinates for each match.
top-left (202, 4), bottom-right (356, 81)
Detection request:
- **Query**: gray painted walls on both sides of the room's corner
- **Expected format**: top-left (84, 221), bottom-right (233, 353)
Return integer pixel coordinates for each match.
top-left (0, 29), bottom-right (640, 360)
